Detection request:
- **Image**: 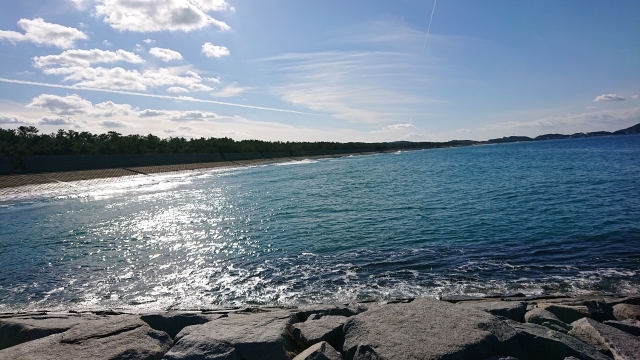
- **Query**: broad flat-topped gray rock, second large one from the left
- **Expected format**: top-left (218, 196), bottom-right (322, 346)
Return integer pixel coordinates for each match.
top-left (165, 311), bottom-right (298, 360)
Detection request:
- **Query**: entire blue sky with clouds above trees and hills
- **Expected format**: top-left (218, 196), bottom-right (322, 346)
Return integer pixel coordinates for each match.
top-left (0, 0), bottom-right (640, 142)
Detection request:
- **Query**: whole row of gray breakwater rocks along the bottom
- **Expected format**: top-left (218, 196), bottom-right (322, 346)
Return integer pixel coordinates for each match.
top-left (0, 296), bottom-right (640, 360)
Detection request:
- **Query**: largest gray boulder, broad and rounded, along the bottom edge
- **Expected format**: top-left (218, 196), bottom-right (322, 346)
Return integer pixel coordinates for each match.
top-left (342, 298), bottom-right (523, 360)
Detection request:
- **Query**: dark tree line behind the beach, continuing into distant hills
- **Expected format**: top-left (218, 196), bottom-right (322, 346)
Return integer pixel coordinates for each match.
top-left (0, 124), bottom-right (640, 174)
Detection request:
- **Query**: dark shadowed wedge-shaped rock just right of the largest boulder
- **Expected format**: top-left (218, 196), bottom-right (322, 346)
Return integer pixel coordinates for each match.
top-left (505, 320), bottom-right (611, 360)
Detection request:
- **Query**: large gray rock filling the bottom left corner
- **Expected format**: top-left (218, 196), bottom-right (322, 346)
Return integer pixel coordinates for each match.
top-left (0, 315), bottom-right (173, 360)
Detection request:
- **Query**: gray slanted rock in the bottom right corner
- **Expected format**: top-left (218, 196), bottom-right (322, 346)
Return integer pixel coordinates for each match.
top-left (569, 318), bottom-right (640, 360)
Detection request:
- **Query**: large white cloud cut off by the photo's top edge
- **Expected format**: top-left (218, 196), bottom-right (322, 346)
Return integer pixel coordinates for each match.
top-left (96, 0), bottom-right (230, 32)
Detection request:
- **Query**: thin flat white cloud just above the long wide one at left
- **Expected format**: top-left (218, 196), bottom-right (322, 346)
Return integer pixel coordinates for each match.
top-left (33, 49), bottom-right (144, 68)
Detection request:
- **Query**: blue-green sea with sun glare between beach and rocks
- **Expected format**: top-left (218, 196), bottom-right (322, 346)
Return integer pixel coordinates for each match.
top-left (0, 136), bottom-right (640, 311)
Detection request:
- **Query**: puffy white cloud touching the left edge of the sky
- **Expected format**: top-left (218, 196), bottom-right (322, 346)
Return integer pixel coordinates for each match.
top-left (0, 18), bottom-right (89, 49)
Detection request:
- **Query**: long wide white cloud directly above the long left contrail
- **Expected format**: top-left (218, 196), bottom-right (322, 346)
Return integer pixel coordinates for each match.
top-left (43, 66), bottom-right (201, 91)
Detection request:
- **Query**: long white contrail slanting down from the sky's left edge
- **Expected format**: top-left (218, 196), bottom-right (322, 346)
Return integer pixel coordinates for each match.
top-left (0, 78), bottom-right (320, 116)
